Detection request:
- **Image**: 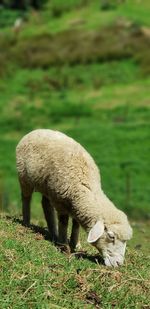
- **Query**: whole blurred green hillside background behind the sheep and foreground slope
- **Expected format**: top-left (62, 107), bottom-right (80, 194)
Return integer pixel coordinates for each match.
top-left (0, 0), bottom-right (150, 219)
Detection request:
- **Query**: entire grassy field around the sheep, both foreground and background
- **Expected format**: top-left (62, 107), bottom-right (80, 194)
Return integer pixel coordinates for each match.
top-left (0, 0), bottom-right (150, 309)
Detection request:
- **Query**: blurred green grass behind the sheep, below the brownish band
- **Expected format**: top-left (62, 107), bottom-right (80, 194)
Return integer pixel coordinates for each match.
top-left (0, 66), bottom-right (150, 218)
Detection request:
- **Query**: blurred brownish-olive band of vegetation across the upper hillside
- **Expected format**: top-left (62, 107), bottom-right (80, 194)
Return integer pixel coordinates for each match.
top-left (3, 23), bottom-right (150, 73)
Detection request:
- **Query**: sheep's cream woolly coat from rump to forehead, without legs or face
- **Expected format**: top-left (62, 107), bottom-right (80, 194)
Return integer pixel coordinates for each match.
top-left (16, 129), bottom-right (129, 240)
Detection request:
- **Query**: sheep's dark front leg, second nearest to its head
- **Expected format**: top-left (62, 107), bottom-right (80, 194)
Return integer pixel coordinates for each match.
top-left (58, 214), bottom-right (69, 244)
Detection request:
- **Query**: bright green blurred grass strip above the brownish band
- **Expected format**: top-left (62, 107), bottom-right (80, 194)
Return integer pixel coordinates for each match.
top-left (0, 0), bottom-right (150, 38)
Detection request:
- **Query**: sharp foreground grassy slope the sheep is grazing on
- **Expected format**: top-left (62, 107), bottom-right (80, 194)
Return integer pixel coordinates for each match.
top-left (0, 217), bottom-right (150, 309)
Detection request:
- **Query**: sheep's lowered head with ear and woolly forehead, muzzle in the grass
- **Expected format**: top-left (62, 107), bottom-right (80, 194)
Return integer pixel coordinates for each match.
top-left (87, 221), bottom-right (132, 267)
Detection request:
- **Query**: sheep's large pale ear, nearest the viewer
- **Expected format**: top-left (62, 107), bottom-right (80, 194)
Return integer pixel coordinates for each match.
top-left (87, 221), bottom-right (104, 243)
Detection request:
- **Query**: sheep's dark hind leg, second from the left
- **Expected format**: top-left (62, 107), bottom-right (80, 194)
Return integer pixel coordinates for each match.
top-left (42, 195), bottom-right (57, 242)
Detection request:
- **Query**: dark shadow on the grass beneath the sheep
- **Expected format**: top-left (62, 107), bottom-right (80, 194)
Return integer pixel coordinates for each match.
top-left (6, 215), bottom-right (104, 265)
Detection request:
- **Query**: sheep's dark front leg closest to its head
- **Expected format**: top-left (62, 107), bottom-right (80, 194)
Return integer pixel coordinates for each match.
top-left (70, 219), bottom-right (80, 252)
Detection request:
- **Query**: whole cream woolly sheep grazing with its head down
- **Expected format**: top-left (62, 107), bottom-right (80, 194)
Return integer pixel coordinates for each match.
top-left (16, 129), bottom-right (132, 267)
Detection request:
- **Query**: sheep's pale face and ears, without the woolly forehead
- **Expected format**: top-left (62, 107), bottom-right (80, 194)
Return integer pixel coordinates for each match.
top-left (88, 221), bottom-right (132, 267)
